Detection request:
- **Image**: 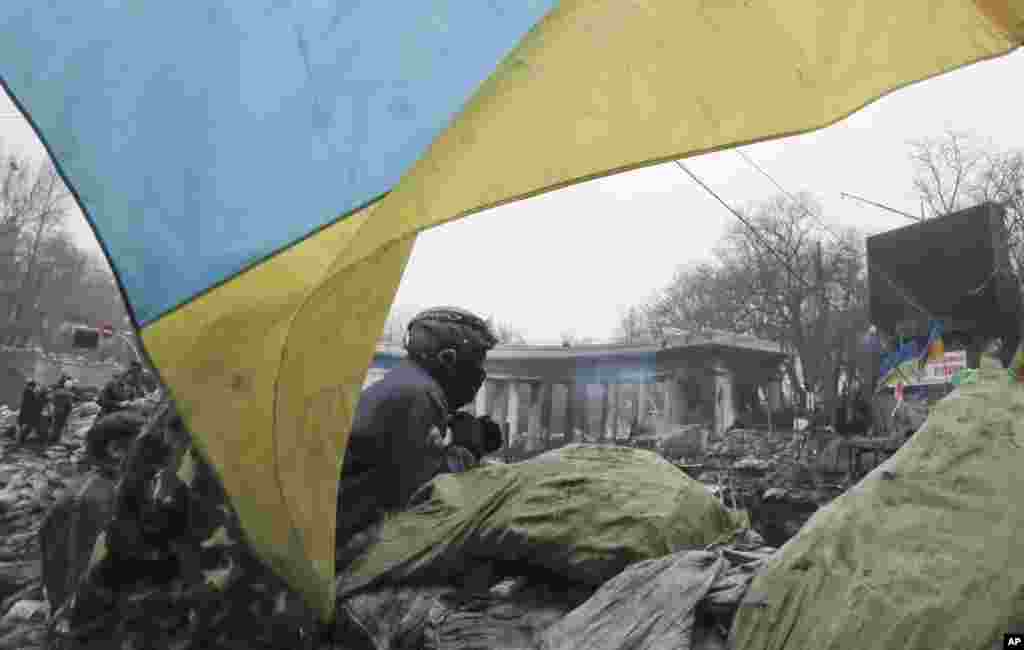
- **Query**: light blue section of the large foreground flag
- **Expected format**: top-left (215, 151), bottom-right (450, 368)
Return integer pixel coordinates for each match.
top-left (0, 0), bottom-right (557, 323)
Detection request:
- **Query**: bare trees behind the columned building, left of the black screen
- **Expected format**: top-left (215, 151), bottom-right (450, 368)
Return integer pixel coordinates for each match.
top-left (647, 194), bottom-right (866, 413)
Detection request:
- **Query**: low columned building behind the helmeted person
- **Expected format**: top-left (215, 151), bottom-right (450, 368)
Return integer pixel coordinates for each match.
top-left (367, 334), bottom-right (785, 449)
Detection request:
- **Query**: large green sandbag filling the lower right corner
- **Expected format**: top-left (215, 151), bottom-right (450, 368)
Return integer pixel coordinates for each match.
top-left (732, 369), bottom-right (1024, 650)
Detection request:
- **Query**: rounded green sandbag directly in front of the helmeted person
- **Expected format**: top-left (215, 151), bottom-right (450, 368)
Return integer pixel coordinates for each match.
top-left (337, 445), bottom-right (739, 596)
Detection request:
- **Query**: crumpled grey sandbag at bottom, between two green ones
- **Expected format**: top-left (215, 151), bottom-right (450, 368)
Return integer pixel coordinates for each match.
top-left (541, 551), bottom-right (728, 650)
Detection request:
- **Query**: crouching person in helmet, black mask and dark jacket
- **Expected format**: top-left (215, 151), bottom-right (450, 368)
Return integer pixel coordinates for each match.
top-left (337, 307), bottom-right (501, 545)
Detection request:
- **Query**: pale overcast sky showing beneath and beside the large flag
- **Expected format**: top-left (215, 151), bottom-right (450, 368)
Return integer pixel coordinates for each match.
top-left (0, 51), bottom-right (1024, 342)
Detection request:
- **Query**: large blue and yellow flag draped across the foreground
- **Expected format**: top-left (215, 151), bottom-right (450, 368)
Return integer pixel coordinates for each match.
top-left (0, 0), bottom-right (1024, 617)
